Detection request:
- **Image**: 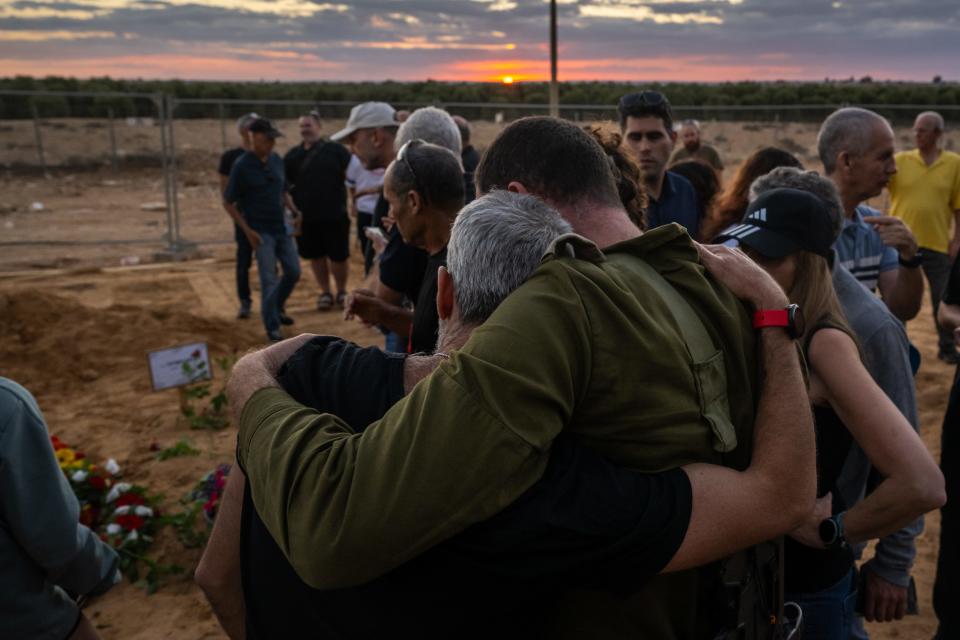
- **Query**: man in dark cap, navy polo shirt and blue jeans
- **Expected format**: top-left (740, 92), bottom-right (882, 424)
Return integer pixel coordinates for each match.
top-left (223, 118), bottom-right (300, 342)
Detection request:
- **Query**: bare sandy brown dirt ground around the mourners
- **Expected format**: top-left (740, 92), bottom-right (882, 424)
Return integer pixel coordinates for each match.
top-left (0, 121), bottom-right (952, 640)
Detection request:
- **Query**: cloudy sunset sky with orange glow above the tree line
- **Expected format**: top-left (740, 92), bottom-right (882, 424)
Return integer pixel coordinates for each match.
top-left (0, 0), bottom-right (960, 81)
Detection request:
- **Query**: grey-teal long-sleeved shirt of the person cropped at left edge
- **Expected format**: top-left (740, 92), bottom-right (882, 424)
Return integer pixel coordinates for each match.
top-left (0, 378), bottom-right (119, 640)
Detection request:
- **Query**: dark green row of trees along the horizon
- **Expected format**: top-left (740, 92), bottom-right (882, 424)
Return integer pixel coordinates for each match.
top-left (0, 76), bottom-right (960, 118)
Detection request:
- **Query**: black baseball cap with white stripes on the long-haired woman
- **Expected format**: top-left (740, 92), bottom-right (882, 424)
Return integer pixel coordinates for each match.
top-left (716, 189), bottom-right (833, 259)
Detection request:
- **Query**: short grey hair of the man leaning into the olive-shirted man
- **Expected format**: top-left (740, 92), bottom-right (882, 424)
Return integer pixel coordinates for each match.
top-left (447, 191), bottom-right (572, 322)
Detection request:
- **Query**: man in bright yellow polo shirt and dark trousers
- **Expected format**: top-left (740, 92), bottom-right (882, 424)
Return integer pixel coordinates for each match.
top-left (887, 111), bottom-right (960, 364)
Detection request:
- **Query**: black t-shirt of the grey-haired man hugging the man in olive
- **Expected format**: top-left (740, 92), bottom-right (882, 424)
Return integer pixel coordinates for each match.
top-left (241, 337), bottom-right (692, 638)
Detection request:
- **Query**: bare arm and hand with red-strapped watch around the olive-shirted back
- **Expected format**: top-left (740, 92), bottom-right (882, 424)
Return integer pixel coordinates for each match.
top-left (665, 246), bottom-right (816, 571)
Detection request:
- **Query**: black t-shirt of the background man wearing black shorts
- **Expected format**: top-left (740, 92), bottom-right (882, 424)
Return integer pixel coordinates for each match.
top-left (283, 140), bottom-right (350, 222)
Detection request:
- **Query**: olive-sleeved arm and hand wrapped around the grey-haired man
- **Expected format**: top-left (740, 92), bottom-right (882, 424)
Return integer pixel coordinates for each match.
top-left (228, 275), bottom-right (590, 588)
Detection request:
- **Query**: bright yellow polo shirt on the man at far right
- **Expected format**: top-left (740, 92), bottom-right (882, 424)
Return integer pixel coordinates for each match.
top-left (887, 149), bottom-right (960, 253)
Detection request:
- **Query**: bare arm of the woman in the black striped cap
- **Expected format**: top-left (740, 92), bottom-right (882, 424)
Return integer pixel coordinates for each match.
top-left (810, 329), bottom-right (945, 542)
